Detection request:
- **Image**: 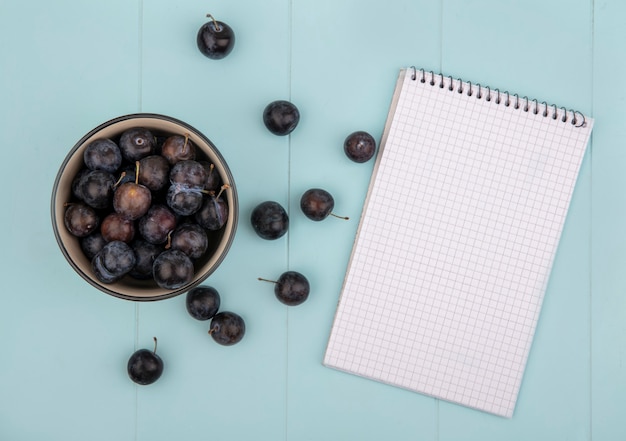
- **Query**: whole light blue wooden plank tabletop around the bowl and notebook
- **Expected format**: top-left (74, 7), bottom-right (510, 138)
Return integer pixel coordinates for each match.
top-left (0, 0), bottom-right (626, 441)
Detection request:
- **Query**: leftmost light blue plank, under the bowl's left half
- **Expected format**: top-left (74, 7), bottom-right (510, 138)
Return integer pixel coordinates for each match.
top-left (0, 0), bottom-right (139, 441)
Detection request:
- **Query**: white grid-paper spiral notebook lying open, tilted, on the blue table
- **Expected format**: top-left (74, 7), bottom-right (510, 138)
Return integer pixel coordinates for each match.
top-left (323, 68), bottom-right (593, 417)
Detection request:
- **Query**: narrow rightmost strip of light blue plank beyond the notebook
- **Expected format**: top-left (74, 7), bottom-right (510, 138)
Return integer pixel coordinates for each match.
top-left (591, 1), bottom-right (626, 440)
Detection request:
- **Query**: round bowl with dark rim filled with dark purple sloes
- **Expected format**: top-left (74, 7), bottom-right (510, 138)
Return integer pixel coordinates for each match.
top-left (51, 113), bottom-right (238, 301)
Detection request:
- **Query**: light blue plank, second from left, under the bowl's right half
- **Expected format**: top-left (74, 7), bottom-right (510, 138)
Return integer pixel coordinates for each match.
top-left (138, 0), bottom-right (289, 439)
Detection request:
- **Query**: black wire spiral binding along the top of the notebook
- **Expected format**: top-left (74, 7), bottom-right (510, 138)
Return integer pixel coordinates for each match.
top-left (411, 66), bottom-right (586, 127)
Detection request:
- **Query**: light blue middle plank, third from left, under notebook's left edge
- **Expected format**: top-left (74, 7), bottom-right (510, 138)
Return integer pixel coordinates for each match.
top-left (287, 0), bottom-right (439, 440)
